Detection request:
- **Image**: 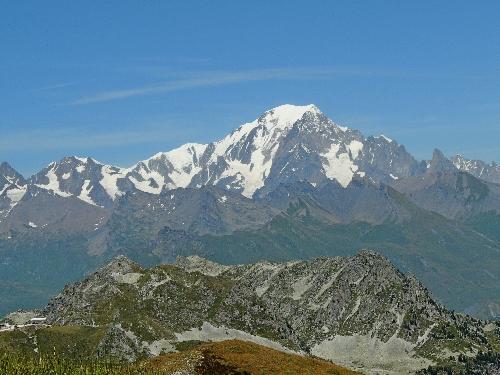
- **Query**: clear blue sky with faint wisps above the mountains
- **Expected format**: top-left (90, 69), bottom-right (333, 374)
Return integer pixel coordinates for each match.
top-left (0, 0), bottom-right (500, 175)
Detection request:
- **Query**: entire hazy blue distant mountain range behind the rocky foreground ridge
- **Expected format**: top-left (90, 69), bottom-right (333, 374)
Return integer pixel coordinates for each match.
top-left (0, 105), bottom-right (500, 317)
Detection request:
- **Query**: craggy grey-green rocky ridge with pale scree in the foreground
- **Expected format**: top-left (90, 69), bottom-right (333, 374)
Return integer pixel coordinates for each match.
top-left (25, 251), bottom-right (499, 374)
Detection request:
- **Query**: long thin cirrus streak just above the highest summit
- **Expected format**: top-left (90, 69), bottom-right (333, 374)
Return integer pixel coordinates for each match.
top-left (68, 68), bottom-right (395, 105)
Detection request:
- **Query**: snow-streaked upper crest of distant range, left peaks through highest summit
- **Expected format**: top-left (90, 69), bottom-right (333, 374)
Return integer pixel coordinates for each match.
top-left (6, 105), bottom-right (419, 207)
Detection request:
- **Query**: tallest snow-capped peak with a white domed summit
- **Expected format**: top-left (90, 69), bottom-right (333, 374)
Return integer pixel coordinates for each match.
top-left (169, 105), bottom-right (418, 197)
